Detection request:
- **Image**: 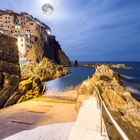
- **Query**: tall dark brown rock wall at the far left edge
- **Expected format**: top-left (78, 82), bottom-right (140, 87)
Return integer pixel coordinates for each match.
top-left (0, 34), bottom-right (20, 108)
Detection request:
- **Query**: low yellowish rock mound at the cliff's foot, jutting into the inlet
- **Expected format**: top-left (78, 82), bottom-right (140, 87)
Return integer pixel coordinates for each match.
top-left (22, 58), bottom-right (70, 81)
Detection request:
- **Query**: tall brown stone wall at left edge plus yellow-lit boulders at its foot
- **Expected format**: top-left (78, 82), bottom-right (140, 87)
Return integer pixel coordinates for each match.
top-left (0, 34), bottom-right (45, 108)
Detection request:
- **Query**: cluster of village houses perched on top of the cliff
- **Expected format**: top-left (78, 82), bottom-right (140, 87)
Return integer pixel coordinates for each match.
top-left (0, 10), bottom-right (51, 57)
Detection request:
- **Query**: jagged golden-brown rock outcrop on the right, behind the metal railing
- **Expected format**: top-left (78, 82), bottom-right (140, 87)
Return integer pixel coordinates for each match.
top-left (76, 65), bottom-right (140, 140)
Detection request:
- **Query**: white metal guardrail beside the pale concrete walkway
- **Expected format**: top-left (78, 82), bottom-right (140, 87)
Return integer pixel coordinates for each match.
top-left (95, 86), bottom-right (129, 140)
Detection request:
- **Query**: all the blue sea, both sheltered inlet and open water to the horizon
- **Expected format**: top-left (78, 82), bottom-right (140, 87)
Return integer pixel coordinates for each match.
top-left (46, 61), bottom-right (140, 101)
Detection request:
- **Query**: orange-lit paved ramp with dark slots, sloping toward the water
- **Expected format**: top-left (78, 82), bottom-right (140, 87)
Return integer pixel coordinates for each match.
top-left (0, 100), bottom-right (77, 139)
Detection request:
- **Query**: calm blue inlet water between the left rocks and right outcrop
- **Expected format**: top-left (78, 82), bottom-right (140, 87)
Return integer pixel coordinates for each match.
top-left (46, 67), bottom-right (95, 91)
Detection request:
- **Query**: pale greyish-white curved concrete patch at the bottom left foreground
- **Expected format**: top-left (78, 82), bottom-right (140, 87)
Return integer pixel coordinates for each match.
top-left (4, 123), bottom-right (73, 140)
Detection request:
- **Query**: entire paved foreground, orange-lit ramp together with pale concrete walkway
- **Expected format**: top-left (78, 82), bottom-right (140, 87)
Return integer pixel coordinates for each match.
top-left (0, 97), bottom-right (108, 140)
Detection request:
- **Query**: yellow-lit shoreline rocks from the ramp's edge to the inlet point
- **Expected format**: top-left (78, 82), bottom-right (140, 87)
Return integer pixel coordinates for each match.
top-left (4, 58), bottom-right (70, 107)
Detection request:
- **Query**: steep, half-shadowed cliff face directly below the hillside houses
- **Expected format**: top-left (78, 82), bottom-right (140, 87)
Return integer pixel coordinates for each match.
top-left (26, 34), bottom-right (70, 66)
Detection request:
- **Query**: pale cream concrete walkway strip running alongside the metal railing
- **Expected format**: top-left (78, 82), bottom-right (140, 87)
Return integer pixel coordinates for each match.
top-left (69, 97), bottom-right (108, 140)
